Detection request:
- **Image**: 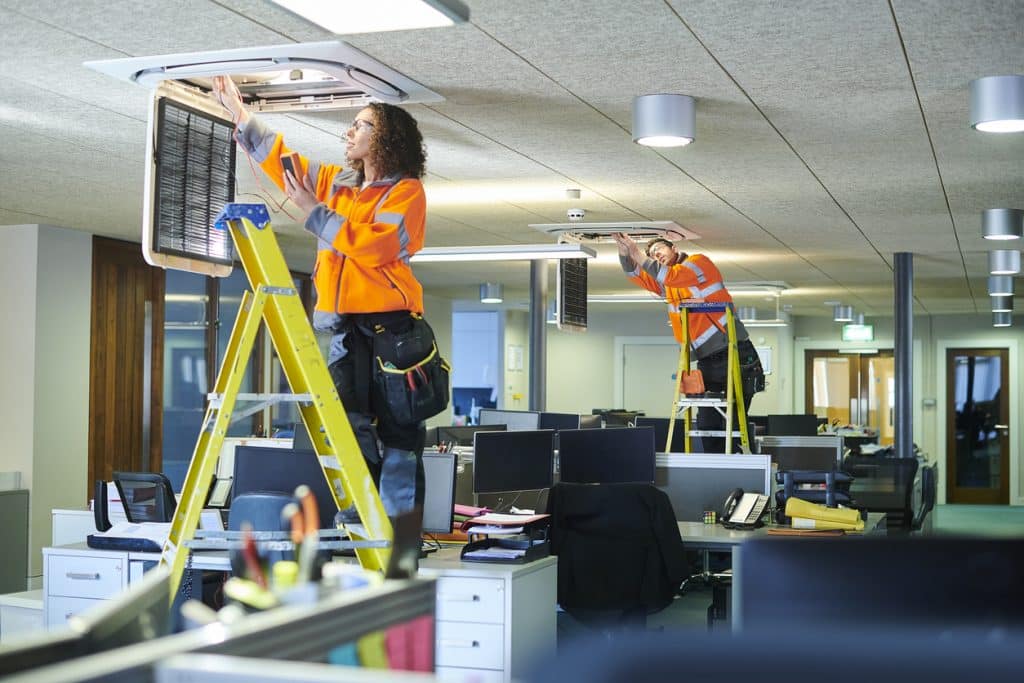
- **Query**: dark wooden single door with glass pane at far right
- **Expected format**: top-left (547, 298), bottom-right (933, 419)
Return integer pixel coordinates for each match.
top-left (945, 348), bottom-right (1010, 505)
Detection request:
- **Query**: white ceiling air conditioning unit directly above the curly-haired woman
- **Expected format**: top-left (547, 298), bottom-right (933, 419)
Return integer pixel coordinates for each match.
top-left (84, 41), bottom-right (444, 112)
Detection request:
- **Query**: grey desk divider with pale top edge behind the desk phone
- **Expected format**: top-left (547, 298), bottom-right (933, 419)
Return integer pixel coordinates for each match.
top-left (654, 453), bottom-right (772, 521)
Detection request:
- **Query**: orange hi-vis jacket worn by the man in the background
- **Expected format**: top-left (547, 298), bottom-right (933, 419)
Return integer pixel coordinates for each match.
top-left (622, 254), bottom-right (748, 360)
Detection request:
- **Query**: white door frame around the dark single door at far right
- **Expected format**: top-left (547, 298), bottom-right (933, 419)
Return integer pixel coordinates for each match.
top-left (934, 337), bottom-right (1024, 505)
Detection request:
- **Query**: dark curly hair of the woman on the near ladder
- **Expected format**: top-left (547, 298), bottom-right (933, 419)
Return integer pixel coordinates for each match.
top-left (351, 102), bottom-right (427, 178)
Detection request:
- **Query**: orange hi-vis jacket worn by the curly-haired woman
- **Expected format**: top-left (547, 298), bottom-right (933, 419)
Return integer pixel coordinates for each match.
top-left (238, 118), bottom-right (427, 317)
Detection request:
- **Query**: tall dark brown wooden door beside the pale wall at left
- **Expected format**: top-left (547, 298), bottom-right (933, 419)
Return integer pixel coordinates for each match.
top-left (88, 237), bottom-right (164, 496)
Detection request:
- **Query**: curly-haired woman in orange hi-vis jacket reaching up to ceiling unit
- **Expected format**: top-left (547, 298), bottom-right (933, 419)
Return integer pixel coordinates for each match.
top-left (214, 76), bottom-right (429, 523)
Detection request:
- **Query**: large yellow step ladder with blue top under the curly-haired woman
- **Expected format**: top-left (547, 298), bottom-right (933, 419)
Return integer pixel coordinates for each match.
top-left (160, 204), bottom-right (392, 602)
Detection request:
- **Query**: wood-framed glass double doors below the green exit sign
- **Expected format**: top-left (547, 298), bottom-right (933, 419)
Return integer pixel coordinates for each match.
top-left (804, 349), bottom-right (895, 445)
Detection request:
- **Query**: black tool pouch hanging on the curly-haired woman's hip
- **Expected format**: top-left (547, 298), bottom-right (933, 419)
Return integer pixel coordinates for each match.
top-left (373, 315), bottom-right (452, 425)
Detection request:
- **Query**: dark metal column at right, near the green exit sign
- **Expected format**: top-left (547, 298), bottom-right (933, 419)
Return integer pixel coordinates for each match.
top-left (893, 252), bottom-right (913, 458)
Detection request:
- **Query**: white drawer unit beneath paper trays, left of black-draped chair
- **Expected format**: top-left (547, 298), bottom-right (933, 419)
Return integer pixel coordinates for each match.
top-left (420, 548), bottom-right (558, 683)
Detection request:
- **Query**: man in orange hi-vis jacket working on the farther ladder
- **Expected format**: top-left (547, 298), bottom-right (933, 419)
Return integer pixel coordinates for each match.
top-left (612, 232), bottom-right (764, 453)
